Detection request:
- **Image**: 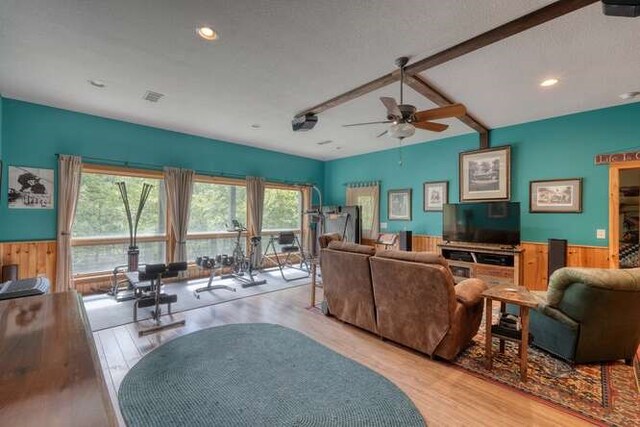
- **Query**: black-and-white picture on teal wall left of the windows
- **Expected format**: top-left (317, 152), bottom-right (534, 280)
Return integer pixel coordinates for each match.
top-left (7, 166), bottom-right (53, 209)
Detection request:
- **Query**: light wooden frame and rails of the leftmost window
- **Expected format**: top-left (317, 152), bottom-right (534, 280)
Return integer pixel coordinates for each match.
top-left (71, 163), bottom-right (173, 284)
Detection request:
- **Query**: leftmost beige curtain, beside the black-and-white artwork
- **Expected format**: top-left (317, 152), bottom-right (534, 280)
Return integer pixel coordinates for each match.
top-left (53, 155), bottom-right (82, 292)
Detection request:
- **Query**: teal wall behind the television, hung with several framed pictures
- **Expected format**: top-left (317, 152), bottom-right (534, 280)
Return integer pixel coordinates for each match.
top-left (324, 103), bottom-right (640, 246)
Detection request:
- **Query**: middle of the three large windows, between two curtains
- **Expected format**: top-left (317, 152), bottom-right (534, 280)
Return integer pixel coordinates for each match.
top-left (187, 181), bottom-right (247, 261)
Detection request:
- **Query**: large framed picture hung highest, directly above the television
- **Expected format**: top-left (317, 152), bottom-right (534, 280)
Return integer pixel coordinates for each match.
top-left (459, 145), bottom-right (511, 202)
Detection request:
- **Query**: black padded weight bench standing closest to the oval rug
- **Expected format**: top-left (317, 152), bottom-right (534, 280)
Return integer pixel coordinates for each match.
top-left (131, 262), bottom-right (187, 336)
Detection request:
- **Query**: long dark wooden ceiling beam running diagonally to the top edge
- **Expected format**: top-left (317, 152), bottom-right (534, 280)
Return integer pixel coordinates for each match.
top-left (296, 0), bottom-right (599, 117)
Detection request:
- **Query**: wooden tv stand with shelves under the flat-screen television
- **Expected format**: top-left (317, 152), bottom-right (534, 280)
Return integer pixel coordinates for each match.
top-left (438, 242), bottom-right (524, 286)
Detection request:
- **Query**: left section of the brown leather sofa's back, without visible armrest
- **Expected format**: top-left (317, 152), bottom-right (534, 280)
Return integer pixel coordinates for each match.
top-left (320, 241), bottom-right (377, 333)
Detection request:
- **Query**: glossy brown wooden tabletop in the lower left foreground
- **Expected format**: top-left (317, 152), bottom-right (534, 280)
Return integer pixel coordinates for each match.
top-left (0, 291), bottom-right (117, 427)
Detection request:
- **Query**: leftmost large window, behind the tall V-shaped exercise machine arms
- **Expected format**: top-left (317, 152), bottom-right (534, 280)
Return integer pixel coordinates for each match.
top-left (72, 166), bottom-right (167, 275)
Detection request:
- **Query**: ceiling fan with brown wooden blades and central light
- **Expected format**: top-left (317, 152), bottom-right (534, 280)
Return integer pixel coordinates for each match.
top-left (343, 56), bottom-right (467, 140)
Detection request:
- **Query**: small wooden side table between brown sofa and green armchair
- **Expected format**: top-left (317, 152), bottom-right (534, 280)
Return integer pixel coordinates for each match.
top-left (482, 285), bottom-right (538, 381)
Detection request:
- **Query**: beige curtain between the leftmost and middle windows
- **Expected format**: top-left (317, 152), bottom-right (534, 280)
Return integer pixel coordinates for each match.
top-left (164, 168), bottom-right (195, 262)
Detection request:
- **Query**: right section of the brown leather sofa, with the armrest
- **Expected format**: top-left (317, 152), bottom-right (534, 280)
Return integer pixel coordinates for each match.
top-left (371, 250), bottom-right (487, 360)
